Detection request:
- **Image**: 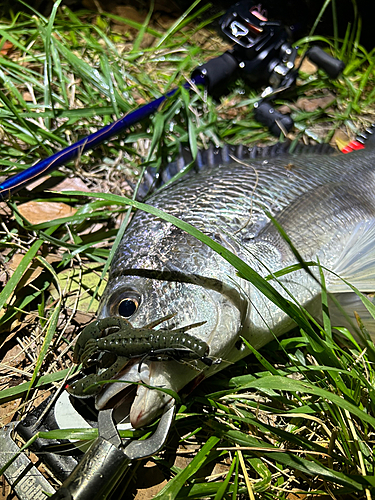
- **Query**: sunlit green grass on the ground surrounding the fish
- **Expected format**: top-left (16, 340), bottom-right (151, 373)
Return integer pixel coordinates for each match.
top-left (0, 2), bottom-right (375, 500)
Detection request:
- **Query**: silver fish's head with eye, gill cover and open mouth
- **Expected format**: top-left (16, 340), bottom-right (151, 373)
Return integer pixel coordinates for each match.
top-left (96, 269), bottom-right (248, 428)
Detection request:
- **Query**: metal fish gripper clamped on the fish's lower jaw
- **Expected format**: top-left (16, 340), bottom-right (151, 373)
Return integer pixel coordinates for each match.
top-left (51, 405), bottom-right (175, 500)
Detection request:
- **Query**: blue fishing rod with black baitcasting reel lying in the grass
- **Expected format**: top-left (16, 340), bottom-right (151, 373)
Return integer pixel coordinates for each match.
top-left (0, 0), bottom-right (345, 200)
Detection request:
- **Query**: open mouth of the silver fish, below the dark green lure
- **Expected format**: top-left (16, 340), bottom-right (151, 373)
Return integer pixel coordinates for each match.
top-left (95, 358), bottom-right (201, 429)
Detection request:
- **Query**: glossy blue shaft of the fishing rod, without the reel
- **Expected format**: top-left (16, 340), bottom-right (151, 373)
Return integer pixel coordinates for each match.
top-left (0, 75), bottom-right (206, 200)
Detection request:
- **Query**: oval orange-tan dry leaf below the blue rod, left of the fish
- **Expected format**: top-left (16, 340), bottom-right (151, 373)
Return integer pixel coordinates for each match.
top-left (18, 201), bottom-right (77, 224)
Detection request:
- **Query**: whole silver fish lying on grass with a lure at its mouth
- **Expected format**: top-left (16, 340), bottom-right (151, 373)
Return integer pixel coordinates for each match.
top-left (70, 134), bottom-right (375, 428)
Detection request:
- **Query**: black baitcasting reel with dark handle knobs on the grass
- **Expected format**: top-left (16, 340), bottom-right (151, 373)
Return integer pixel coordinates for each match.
top-left (192, 0), bottom-right (345, 136)
